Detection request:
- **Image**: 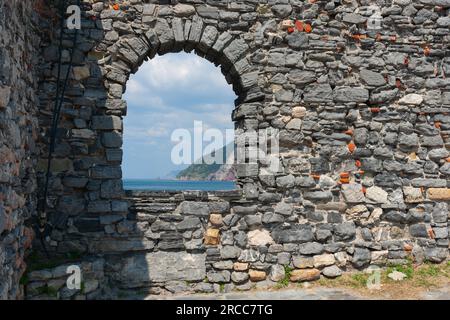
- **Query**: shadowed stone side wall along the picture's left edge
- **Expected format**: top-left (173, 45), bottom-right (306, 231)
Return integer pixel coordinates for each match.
top-left (0, 0), bottom-right (39, 299)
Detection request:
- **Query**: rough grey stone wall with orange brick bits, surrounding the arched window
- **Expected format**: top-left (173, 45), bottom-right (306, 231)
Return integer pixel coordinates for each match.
top-left (0, 0), bottom-right (450, 299)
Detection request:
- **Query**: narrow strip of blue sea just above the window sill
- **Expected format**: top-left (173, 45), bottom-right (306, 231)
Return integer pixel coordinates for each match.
top-left (123, 179), bottom-right (236, 191)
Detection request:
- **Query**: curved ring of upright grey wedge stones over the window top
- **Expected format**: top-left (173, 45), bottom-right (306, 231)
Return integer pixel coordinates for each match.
top-left (95, 5), bottom-right (264, 189)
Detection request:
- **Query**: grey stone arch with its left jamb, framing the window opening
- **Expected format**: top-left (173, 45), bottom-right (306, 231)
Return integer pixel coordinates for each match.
top-left (92, 4), bottom-right (265, 210)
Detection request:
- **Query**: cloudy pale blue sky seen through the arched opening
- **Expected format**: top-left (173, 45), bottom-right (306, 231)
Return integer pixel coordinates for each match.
top-left (122, 53), bottom-right (236, 179)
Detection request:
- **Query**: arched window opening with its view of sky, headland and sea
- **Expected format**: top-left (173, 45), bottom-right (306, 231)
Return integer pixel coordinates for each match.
top-left (122, 53), bottom-right (236, 191)
